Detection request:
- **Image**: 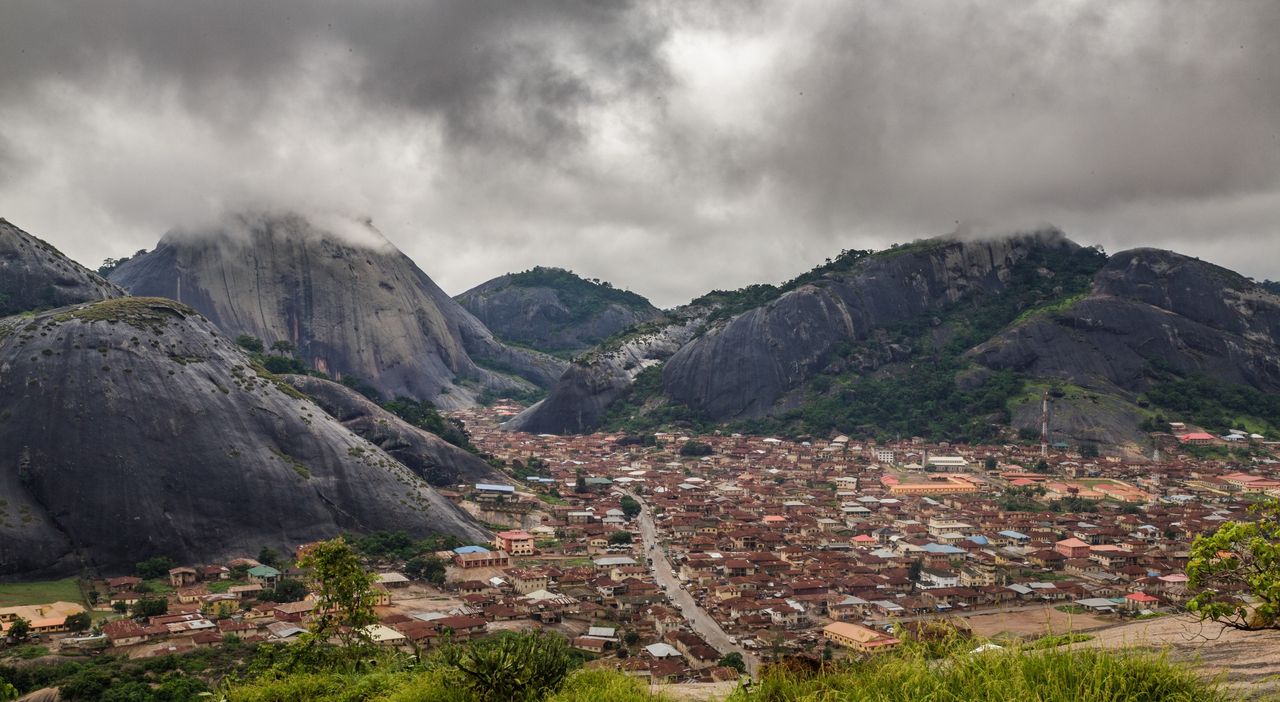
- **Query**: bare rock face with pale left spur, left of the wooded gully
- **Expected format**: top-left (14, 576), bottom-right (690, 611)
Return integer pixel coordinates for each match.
top-left (507, 229), bottom-right (1079, 433)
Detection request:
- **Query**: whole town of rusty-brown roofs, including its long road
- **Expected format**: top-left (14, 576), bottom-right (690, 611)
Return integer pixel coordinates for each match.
top-left (0, 404), bottom-right (1280, 683)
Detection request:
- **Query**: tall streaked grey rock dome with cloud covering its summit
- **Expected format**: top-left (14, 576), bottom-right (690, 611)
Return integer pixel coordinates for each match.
top-left (110, 214), bottom-right (564, 407)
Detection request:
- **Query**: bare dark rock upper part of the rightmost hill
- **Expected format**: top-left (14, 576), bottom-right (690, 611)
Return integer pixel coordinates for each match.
top-left (972, 249), bottom-right (1280, 395)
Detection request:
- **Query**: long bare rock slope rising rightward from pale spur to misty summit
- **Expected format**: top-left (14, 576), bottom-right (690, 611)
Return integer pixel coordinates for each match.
top-left (511, 231), bottom-right (1092, 430)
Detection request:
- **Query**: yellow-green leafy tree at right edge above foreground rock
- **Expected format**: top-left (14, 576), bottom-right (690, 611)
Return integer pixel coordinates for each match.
top-left (1187, 500), bottom-right (1280, 632)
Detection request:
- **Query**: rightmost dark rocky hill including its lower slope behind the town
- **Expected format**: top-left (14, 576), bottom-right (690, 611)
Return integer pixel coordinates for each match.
top-left (969, 249), bottom-right (1280, 443)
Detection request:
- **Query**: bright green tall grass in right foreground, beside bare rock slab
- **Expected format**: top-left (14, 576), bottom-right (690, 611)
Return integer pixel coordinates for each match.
top-left (730, 648), bottom-right (1234, 702)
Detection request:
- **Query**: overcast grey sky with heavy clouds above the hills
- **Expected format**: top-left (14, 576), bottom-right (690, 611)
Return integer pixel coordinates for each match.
top-left (0, 0), bottom-right (1280, 306)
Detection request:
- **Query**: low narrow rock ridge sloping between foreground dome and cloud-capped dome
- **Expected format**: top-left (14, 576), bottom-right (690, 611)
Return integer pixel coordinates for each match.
top-left (282, 375), bottom-right (504, 487)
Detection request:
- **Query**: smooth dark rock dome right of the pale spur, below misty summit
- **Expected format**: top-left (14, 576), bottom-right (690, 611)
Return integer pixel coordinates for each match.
top-left (663, 231), bottom-right (1078, 420)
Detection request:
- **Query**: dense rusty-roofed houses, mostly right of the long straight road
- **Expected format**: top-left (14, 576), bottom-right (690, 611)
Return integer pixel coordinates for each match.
top-left (460, 407), bottom-right (1280, 651)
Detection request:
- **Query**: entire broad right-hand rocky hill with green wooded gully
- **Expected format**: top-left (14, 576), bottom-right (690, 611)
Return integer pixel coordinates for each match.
top-left (509, 229), bottom-right (1280, 445)
